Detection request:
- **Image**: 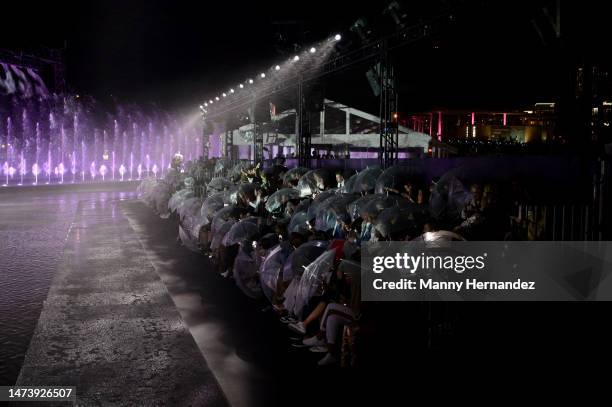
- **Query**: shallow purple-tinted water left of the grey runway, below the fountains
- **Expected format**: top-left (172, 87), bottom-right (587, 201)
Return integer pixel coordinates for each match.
top-left (0, 183), bottom-right (134, 385)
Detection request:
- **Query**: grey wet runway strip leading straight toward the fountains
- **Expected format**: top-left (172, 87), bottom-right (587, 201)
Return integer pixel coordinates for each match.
top-left (17, 196), bottom-right (227, 406)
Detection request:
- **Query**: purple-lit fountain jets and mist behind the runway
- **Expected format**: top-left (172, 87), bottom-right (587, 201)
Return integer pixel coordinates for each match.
top-left (0, 96), bottom-right (201, 186)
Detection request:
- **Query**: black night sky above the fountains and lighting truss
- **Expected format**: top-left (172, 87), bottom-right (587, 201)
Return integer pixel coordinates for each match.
top-left (0, 0), bottom-right (609, 111)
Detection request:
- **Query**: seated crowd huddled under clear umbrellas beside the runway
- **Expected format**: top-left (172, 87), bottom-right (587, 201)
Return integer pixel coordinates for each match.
top-left (140, 156), bottom-right (532, 366)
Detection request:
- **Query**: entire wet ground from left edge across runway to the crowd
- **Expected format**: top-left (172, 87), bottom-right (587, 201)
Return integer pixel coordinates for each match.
top-left (0, 189), bottom-right (346, 407)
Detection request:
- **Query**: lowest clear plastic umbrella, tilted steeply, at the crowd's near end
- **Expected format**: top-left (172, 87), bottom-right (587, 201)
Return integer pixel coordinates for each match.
top-left (293, 249), bottom-right (336, 316)
